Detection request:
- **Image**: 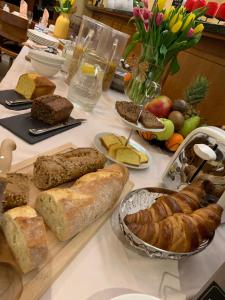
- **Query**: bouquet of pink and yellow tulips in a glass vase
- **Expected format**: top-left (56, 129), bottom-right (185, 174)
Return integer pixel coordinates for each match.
top-left (124, 0), bottom-right (205, 104)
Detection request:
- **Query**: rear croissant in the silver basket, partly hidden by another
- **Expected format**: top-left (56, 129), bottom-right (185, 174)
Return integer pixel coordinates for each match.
top-left (124, 181), bottom-right (207, 224)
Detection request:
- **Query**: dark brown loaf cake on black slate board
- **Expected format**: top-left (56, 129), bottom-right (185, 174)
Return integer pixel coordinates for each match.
top-left (31, 95), bottom-right (73, 125)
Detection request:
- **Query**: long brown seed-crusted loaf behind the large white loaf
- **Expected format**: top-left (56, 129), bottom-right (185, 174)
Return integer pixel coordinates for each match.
top-left (33, 148), bottom-right (106, 190)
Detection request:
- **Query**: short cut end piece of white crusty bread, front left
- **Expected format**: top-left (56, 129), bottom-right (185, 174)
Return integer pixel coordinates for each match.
top-left (2, 206), bottom-right (48, 273)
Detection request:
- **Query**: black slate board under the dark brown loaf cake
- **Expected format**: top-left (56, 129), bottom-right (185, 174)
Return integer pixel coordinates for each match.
top-left (0, 113), bottom-right (81, 144)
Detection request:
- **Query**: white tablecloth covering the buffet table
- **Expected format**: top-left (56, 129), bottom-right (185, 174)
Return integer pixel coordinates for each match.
top-left (0, 46), bottom-right (225, 300)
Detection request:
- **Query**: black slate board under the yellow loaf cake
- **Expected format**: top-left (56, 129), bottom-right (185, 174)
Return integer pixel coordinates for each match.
top-left (0, 90), bottom-right (32, 110)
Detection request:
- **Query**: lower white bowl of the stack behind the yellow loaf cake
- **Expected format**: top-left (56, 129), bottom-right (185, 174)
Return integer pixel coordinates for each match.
top-left (30, 57), bottom-right (61, 77)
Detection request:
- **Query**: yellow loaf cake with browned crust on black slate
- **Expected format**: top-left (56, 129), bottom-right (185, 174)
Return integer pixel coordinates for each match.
top-left (16, 73), bottom-right (56, 99)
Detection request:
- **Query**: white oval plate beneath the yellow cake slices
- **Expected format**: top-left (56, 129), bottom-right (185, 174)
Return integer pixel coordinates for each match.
top-left (93, 132), bottom-right (151, 170)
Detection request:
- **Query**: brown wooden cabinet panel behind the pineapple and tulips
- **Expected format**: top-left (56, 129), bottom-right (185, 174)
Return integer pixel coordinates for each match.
top-left (163, 33), bottom-right (225, 126)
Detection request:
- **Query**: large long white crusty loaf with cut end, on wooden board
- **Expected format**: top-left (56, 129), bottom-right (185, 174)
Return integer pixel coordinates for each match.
top-left (35, 164), bottom-right (128, 241)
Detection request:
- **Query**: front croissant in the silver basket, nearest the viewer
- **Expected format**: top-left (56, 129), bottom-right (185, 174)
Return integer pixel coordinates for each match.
top-left (128, 204), bottom-right (223, 253)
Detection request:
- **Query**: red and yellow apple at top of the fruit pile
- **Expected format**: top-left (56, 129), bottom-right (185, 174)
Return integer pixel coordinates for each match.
top-left (145, 96), bottom-right (173, 118)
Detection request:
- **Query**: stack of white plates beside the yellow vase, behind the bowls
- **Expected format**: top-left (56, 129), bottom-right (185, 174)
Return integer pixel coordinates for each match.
top-left (27, 29), bottom-right (59, 47)
